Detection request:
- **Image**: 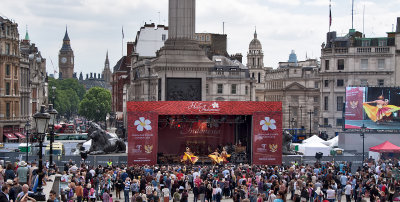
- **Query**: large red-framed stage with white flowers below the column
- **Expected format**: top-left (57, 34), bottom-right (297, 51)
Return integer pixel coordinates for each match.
top-left (127, 101), bottom-right (282, 165)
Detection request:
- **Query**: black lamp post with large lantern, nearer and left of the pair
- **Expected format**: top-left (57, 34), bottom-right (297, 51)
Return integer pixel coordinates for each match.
top-left (33, 105), bottom-right (50, 201)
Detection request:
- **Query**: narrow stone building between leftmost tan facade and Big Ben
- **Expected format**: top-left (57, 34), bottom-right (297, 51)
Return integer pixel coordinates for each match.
top-left (20, 32), bottom-right (48, 120)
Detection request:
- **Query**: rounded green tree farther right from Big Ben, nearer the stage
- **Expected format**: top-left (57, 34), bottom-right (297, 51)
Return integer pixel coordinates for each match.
top-left (79, 87), bottom-right (111, 122)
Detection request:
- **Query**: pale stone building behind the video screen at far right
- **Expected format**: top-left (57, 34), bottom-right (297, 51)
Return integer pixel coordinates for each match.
top-left (319, 18), bottom-right (400, 136)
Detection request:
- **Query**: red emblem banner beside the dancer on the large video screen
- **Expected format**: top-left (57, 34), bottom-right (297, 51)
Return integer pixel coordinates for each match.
top-left (345, 87), bottom-right (365, 120)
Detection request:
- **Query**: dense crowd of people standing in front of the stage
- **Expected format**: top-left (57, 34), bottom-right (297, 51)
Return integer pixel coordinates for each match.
top-left (0, 159), bottom-right (400, 202)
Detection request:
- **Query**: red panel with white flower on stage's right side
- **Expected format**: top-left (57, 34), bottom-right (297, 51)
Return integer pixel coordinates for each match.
top-left (253, 112), bottom-right (282, 165)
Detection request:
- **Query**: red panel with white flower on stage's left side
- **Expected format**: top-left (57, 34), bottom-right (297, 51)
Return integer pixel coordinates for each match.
top-left (128, 112), bottom-right (158, 165)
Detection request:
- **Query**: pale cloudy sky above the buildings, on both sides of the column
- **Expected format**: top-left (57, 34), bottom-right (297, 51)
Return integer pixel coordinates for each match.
top-left (0, 0), bottom-right (400, 76)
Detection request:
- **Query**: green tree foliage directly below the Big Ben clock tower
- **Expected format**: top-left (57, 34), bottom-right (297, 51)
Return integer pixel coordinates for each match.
top-left (48, 78), bottom-right (85, 118)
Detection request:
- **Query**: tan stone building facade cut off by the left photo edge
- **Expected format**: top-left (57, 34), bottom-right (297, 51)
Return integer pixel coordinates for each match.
top-left (0, 17), bottom-right (21, 142)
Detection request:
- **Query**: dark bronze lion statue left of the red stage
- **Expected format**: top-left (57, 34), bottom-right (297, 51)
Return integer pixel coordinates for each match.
top-left (88, 122), bottom-right (126, 155)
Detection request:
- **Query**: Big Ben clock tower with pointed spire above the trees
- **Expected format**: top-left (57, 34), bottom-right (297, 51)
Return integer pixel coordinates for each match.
top-left (58, 29), bottom-right (74, 79)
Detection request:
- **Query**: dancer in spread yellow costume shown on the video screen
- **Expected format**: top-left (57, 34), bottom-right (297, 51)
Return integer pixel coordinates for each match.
top-left (363, 95), bottom-right (400, 123)
